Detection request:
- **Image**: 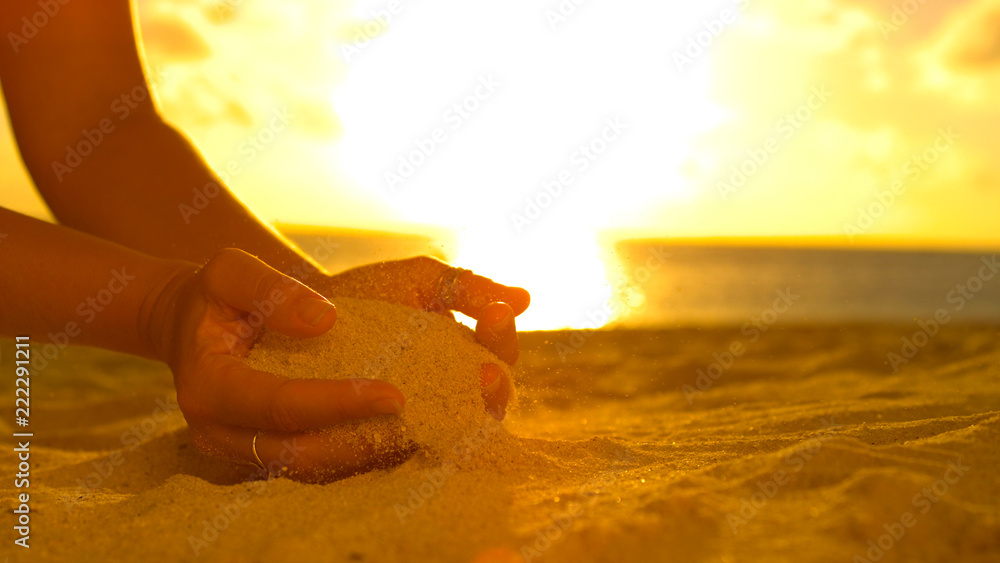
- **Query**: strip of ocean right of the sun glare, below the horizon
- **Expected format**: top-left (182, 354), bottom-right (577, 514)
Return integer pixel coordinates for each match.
top-left (616, 245), bottom-right (1000, 327)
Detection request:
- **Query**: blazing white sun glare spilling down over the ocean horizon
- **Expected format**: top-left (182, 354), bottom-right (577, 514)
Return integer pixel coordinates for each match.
top-left (316, 3), bottom-right (723, 330)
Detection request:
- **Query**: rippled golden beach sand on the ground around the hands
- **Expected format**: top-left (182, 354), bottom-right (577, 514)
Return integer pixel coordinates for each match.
top-left (0, 324), bottom-right (1000, 563)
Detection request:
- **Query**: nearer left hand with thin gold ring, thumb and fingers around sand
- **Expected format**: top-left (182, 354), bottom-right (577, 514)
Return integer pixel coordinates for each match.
top-left (146, 249), bottom-right (409, 481)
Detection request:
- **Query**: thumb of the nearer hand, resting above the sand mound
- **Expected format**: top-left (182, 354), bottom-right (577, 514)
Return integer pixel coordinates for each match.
top-left (199, 248), bottom-right (337, 337)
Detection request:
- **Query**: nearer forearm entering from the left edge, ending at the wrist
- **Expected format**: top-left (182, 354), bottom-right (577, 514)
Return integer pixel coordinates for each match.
top-left (0, 209), bottom-right (196, 359)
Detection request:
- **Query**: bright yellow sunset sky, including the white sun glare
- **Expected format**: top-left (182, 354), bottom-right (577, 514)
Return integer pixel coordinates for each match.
top-left (0, 0), bottom-right (1000, 328)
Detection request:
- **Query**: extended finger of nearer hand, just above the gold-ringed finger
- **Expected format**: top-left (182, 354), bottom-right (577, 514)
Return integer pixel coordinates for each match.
top-left (184, 355), bottom-right (405, 432)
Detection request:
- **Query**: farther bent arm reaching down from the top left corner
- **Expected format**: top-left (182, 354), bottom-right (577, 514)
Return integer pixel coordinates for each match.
top-left (0, 0), bottom-right (317, 286)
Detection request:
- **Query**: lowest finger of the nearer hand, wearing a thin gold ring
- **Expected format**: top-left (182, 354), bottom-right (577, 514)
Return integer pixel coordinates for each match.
top-left (192, 424), bottom-right (414, 483)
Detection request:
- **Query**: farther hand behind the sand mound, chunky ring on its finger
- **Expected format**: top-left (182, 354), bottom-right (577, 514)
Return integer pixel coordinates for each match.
top-left (317, 256), bottom-right (531, 420)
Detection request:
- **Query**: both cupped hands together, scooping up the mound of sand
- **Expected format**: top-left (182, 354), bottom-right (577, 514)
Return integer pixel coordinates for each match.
top-left (149, 249), bottom-right (529, 482)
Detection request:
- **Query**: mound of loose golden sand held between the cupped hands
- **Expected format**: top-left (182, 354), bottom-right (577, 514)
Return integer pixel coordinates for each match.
top-left (246, 297), bottom-right (510, 464)
